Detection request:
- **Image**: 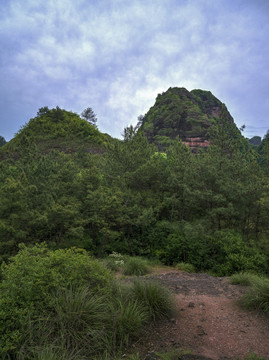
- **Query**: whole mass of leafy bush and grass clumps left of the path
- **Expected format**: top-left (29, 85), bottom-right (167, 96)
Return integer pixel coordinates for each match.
top-left (0, 244), bottom-right (174, 360)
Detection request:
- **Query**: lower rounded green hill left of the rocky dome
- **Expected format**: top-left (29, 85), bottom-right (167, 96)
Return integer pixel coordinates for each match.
top-left (0, 107), bottom-right (112, 160)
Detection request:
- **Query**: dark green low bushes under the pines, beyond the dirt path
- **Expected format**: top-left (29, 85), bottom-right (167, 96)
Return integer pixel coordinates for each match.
top-left (156, 228), bottom-right (267, 276)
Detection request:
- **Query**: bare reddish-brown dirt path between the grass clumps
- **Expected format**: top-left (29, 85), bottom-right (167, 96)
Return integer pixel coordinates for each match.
top-left (133, 271), bottom-right (269, 360)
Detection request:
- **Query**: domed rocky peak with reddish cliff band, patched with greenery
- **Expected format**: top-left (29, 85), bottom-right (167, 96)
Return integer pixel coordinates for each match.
top-left (141, 88), bottom-right (233, 152)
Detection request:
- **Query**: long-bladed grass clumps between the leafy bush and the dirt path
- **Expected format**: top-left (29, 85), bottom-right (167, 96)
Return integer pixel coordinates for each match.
top-left (14, 279), bottom-right (175, 360)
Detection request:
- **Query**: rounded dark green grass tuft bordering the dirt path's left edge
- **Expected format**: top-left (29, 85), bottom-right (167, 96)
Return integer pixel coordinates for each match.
top-left (131, 280), bottom-right (175, 320)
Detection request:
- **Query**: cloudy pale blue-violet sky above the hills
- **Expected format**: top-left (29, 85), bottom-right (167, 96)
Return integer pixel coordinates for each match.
top-left (0, 0), bottom-right (269, 141)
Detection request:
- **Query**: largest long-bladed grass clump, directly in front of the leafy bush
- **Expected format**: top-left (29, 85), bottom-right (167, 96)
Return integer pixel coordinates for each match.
top-left (20, 287), bottom-right (112, 360)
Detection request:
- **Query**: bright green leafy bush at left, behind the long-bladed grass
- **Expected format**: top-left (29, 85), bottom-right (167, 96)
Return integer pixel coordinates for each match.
top-left (0, 244), bottom-right (112, 355)
